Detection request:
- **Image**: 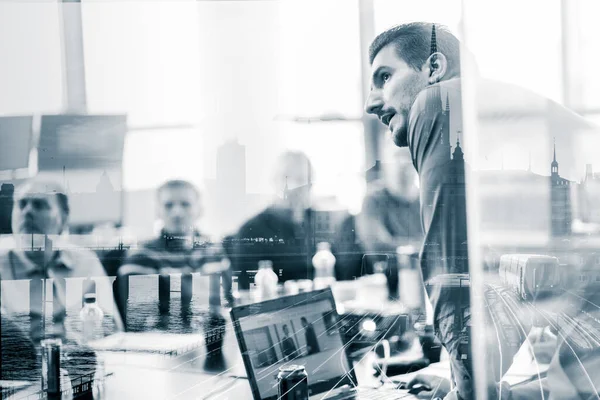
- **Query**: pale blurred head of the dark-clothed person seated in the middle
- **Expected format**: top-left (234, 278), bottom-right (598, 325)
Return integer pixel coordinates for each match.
top-left (273, 151), bottom-right (314, 208)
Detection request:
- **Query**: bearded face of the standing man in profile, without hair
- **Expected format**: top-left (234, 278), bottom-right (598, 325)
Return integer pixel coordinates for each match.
top-left (365, 44), bottom-right (428, 147)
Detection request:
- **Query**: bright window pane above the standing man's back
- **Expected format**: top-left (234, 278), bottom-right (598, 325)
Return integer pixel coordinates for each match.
top-left (466, 0), bottom-right (562, 102)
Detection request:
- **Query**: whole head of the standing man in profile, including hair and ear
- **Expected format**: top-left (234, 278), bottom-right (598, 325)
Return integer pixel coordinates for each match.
top-left (365, 22), bottom-right (460, 147)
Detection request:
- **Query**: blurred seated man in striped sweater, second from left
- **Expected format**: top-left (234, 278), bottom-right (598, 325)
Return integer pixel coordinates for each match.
top-left (118, 180), bottom-right (231, 328)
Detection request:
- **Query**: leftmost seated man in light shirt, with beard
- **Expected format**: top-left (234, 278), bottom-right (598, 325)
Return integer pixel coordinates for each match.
top-left (0, 179), bottom-right (122, 388)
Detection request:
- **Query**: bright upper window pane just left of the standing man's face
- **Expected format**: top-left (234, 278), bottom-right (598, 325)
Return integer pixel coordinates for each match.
top-left (277, 0), bottom-right (362, 118)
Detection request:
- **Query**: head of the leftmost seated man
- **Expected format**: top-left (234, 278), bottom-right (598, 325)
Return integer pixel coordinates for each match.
top-left (12, 179), bottom-right (69, 235)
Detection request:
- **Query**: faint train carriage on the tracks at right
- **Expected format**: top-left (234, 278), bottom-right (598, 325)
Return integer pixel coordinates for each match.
top-left (499, 254), bottom-right (560, 300)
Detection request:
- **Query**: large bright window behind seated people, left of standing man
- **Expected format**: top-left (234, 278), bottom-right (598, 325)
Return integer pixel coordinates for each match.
top-left (82, 1), bottom-right (364, 236)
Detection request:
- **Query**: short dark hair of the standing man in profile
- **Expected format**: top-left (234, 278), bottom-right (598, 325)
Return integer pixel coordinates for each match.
top-left (369, 22), bottom-right (460, 73)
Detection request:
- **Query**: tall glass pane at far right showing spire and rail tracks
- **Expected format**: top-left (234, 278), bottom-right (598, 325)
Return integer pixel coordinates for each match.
top-left (462, 1), bottom-right (600, 398)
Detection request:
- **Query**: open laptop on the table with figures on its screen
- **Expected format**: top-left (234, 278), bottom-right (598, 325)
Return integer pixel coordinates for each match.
top-left (231, 289), bottom-right (416, 400)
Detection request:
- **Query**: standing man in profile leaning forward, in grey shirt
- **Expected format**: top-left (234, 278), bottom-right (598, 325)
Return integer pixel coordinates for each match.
top-left (365, 23), bottom-right (474, 399)
